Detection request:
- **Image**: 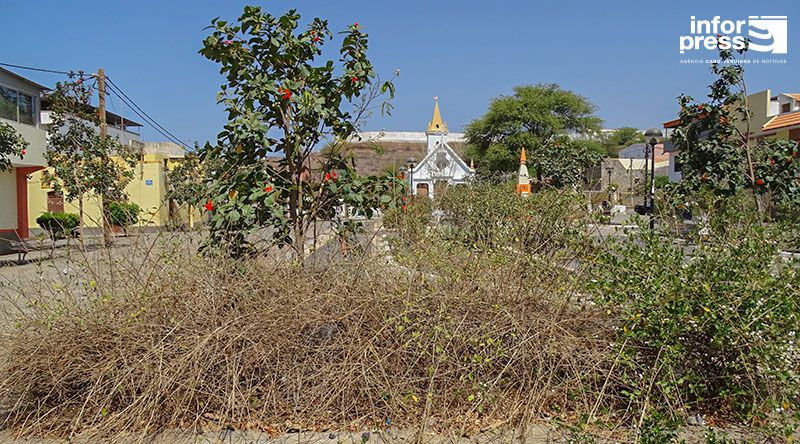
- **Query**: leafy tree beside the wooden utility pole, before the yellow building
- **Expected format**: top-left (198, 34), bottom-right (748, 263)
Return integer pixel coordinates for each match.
top-left (42, 73), bottom-right (139, 245)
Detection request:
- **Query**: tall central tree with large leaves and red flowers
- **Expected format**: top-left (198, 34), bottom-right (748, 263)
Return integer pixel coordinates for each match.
top-left (200, 6), bottom-right (394, 259)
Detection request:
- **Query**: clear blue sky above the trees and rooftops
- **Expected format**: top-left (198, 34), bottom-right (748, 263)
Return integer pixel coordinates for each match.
top-left (0, 0), bottom-right (800, 142)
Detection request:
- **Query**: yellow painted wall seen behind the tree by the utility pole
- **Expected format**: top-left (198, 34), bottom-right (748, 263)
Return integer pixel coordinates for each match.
top-left (26, 154), bottom-right (201, 228)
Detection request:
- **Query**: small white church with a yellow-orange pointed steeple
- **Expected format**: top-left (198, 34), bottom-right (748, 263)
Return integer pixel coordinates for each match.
top-left (408, 98), bottom-right (475, 198)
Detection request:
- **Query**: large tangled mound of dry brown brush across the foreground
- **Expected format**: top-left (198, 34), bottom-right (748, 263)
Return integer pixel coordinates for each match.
top-left (0, 224), bottom-right (611, 437)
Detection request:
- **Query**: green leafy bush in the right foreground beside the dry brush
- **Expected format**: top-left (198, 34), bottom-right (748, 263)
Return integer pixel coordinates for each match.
top-left (589, 217), bottom-right (800, 420)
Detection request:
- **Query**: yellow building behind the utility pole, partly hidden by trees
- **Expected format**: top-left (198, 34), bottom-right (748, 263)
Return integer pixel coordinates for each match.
top-left (28, 142), bottom-right (202, 232)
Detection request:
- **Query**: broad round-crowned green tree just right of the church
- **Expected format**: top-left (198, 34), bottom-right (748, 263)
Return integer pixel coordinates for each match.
top-left (466, 84), bottom-right (602, 183)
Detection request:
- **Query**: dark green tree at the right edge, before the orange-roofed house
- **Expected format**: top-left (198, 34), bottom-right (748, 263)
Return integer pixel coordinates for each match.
top-left (672, 49), bottom-right (800, 213)
